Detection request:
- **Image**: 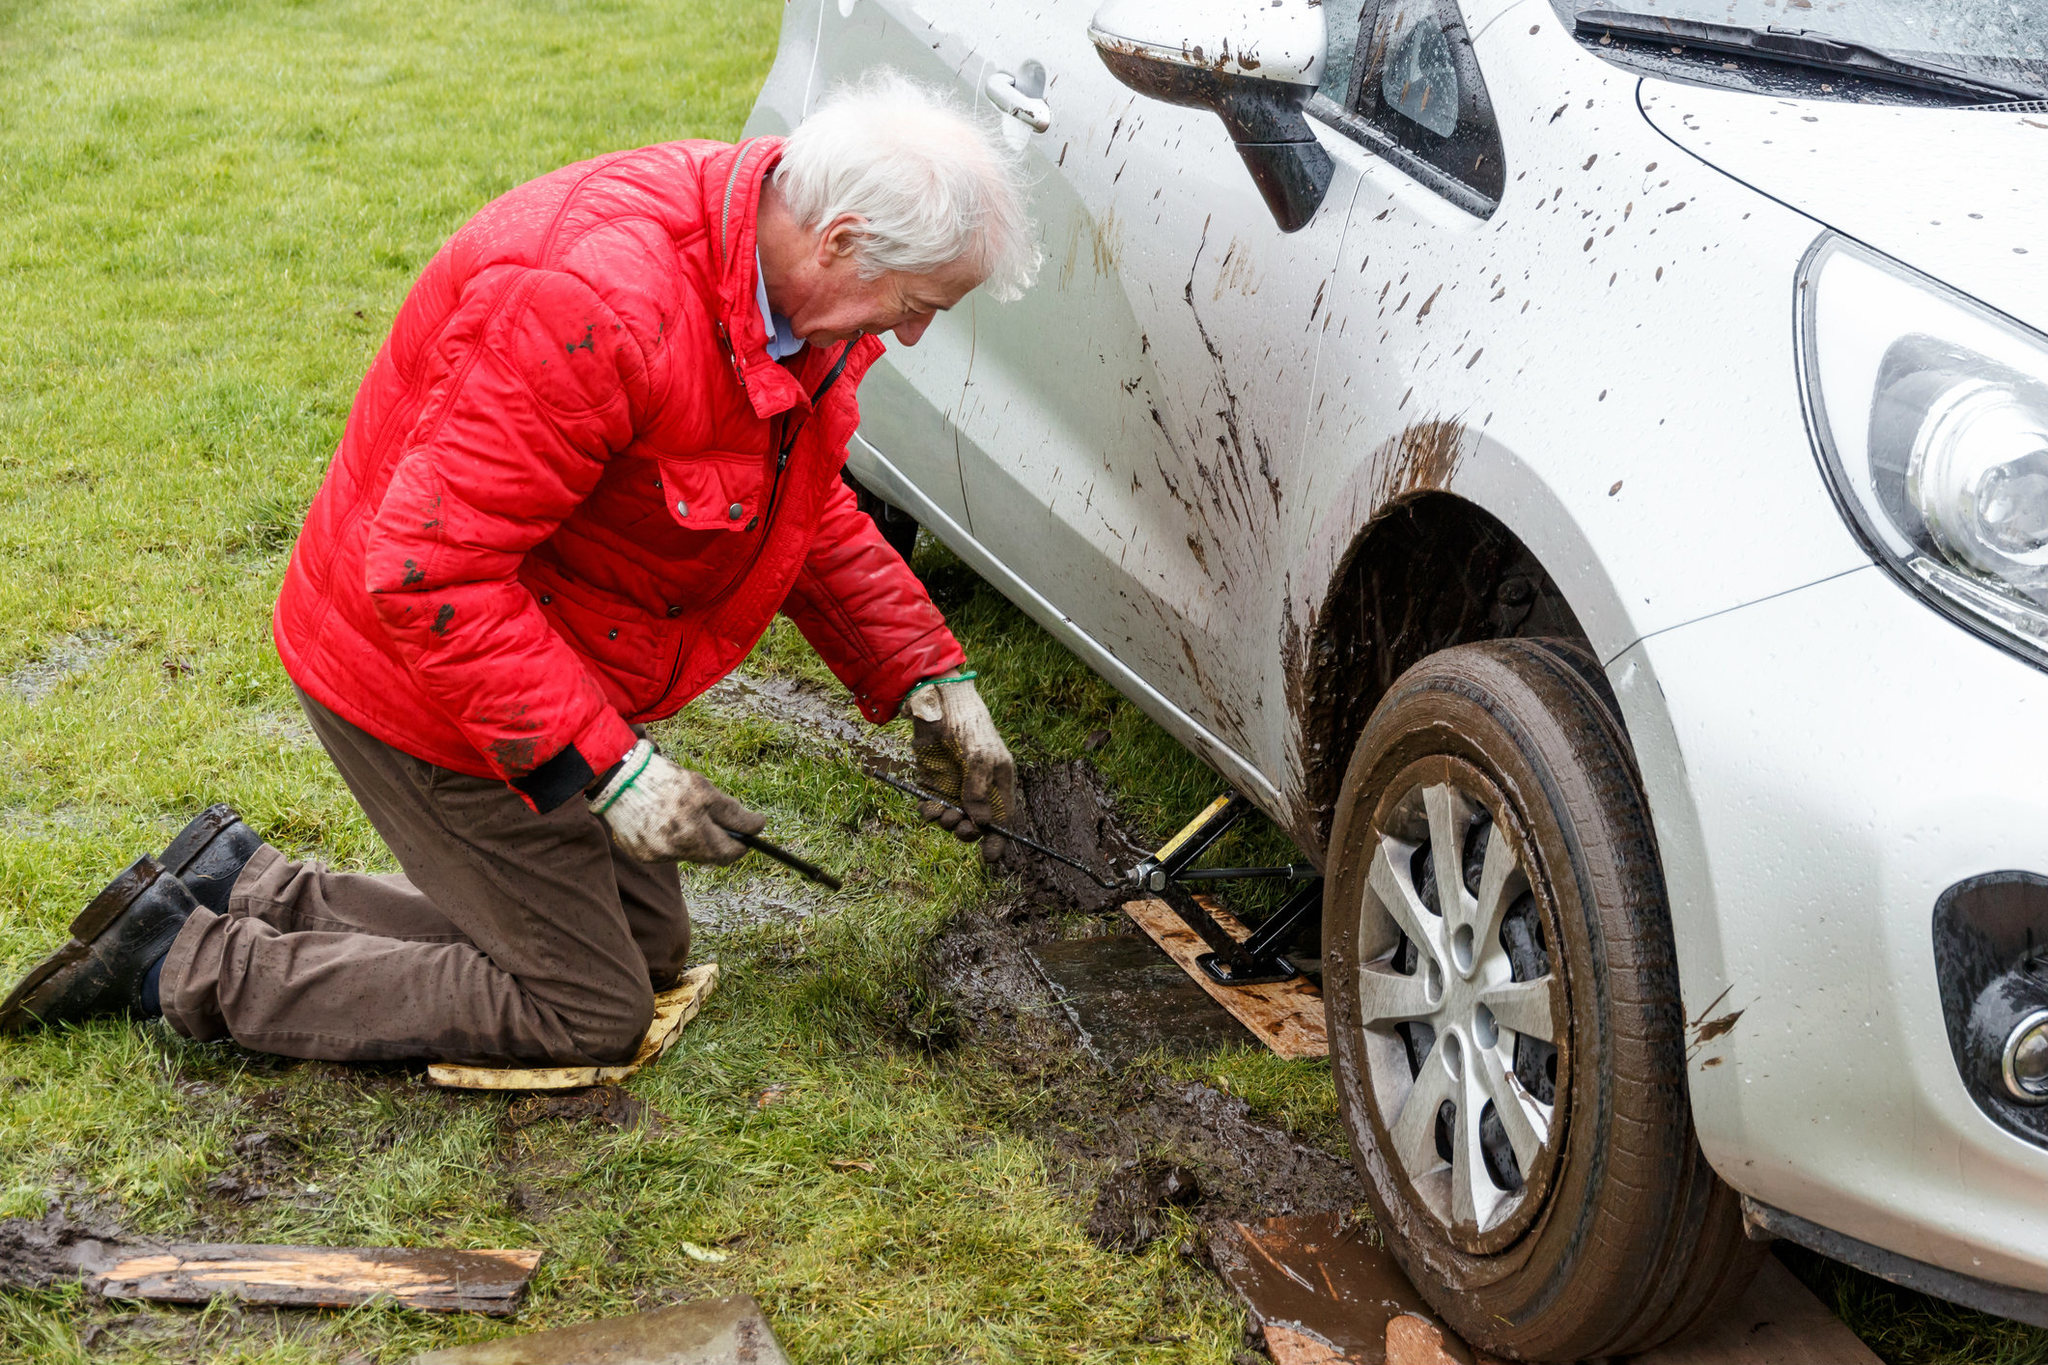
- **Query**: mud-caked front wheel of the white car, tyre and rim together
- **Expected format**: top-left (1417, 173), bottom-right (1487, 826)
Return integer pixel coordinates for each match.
top-left (1323, 641), bottom-right (1763, 1361)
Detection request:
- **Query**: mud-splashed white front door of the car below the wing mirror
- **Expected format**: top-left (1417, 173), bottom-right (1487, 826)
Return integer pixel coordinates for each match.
top-left (952, 0), bottom-right (1358, 774)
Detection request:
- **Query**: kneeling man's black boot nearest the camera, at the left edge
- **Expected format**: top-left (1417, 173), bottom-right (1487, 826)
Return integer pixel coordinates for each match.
top-left (0, 857), bottom-right (199, 1033)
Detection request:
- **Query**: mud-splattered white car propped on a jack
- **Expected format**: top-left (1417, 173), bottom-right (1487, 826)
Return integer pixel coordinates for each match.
top-left (748, 0), bottom-right (2048, 1361)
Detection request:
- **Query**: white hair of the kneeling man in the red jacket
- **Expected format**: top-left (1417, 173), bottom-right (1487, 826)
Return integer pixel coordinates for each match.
top-left (774, 68), bottom-right (1040, 299)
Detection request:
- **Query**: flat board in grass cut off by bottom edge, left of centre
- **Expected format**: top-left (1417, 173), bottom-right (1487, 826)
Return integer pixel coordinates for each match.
top-left (410, 1293), bottom-right (788, 1365)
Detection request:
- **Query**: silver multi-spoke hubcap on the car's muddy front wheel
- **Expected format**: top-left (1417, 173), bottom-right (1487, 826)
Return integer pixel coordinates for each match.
top-left (1358, 759), bottom-right (1567, 1252)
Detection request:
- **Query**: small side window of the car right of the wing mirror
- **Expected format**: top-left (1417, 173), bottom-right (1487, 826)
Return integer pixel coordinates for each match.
top-left (1311, 0), bottom-right (1507, 217)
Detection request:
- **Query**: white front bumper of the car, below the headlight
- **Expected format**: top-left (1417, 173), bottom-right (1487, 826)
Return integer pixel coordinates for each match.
top-left (1608, 567), bottom-right (2048, 1291)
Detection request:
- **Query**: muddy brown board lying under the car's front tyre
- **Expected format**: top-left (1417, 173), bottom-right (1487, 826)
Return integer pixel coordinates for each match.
top-left (1210, 1214), bottom-right (1878, 1365)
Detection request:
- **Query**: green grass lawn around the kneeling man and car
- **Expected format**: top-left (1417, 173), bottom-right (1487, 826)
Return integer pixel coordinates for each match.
top-left (0, 0), bottom-right (2048, 1365)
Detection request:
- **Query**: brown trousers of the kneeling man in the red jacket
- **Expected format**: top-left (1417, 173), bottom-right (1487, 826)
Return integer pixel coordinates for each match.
top-left (162, 694), bottom-right (690, 1066)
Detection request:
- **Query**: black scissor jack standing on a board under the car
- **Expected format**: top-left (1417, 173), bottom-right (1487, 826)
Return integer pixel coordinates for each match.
top-left (1130, 792), bottom-right (1323, 986)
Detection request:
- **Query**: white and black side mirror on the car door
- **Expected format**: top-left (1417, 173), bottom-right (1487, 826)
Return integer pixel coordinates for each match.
top-left (1087, 0), bottom-right (1335, 231)
